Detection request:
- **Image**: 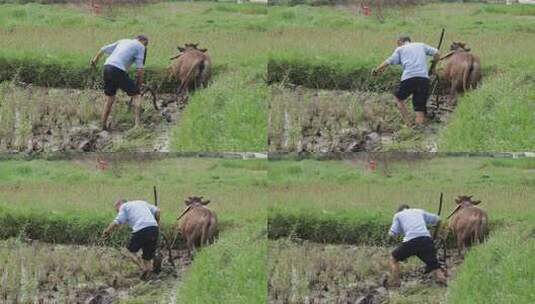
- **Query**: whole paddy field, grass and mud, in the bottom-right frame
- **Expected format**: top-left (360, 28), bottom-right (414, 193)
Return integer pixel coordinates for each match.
top-left (268, 153), bottom-right (535, 303)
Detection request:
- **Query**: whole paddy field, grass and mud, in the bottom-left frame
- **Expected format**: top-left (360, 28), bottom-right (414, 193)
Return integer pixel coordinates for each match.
top-left (0, 154), bottom-right (268, 303)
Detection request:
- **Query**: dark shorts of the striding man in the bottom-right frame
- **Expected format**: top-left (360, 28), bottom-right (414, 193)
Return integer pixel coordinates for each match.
top-left (392, 236), bottom-right (440, 272)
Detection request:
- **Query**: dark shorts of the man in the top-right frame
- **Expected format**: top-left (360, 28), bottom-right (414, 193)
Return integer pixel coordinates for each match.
top-left (394, 77), bottom-right (429, 112)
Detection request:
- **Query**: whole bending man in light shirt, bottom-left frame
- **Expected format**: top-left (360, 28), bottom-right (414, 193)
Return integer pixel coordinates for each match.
top-left (102, 199), bottom-right (160, 279)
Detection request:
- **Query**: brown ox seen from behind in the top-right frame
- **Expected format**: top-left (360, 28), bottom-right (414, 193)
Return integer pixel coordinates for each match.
top-left (444, 42), bottom-right (481, 100)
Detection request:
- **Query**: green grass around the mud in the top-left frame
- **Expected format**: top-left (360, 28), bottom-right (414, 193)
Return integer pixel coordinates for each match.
top-left (0, 2), bottom-right (270, 151)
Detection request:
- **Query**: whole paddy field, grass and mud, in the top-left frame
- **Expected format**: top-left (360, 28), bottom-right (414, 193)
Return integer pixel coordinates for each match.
top-left (0, 2), bottom-right (269, 152)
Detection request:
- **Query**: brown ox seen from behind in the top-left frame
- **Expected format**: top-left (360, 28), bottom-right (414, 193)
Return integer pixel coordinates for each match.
top-left (170, 43), bottom-right (212, 96)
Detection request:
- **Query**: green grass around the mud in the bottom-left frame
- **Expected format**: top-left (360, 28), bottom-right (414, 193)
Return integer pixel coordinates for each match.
top-left (0, 154), bottom-right (268, 303)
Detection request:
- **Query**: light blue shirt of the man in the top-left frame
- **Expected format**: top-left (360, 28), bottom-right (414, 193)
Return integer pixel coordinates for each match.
top-left (100, 39), bottom-right (145, 72)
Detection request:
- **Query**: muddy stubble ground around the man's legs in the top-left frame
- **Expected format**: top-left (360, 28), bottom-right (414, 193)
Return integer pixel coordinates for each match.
top-left (0, 84), bottom-right (185, 153)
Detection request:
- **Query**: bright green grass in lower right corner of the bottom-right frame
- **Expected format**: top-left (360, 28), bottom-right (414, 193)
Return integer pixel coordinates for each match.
top-left (448, 222), bottom-right (535, 304)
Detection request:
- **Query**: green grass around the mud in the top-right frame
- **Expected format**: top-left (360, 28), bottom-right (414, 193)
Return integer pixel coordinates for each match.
top-left (268, 3), bottom-right (535, 151)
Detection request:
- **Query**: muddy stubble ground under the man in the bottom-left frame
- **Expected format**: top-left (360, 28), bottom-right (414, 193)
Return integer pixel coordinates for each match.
top-left (0, 240), bottom-right (191, 304)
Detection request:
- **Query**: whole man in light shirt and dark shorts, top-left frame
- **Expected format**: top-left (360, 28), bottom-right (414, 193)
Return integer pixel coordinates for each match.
top-left (91, 35), bottom-right (149, 130)
